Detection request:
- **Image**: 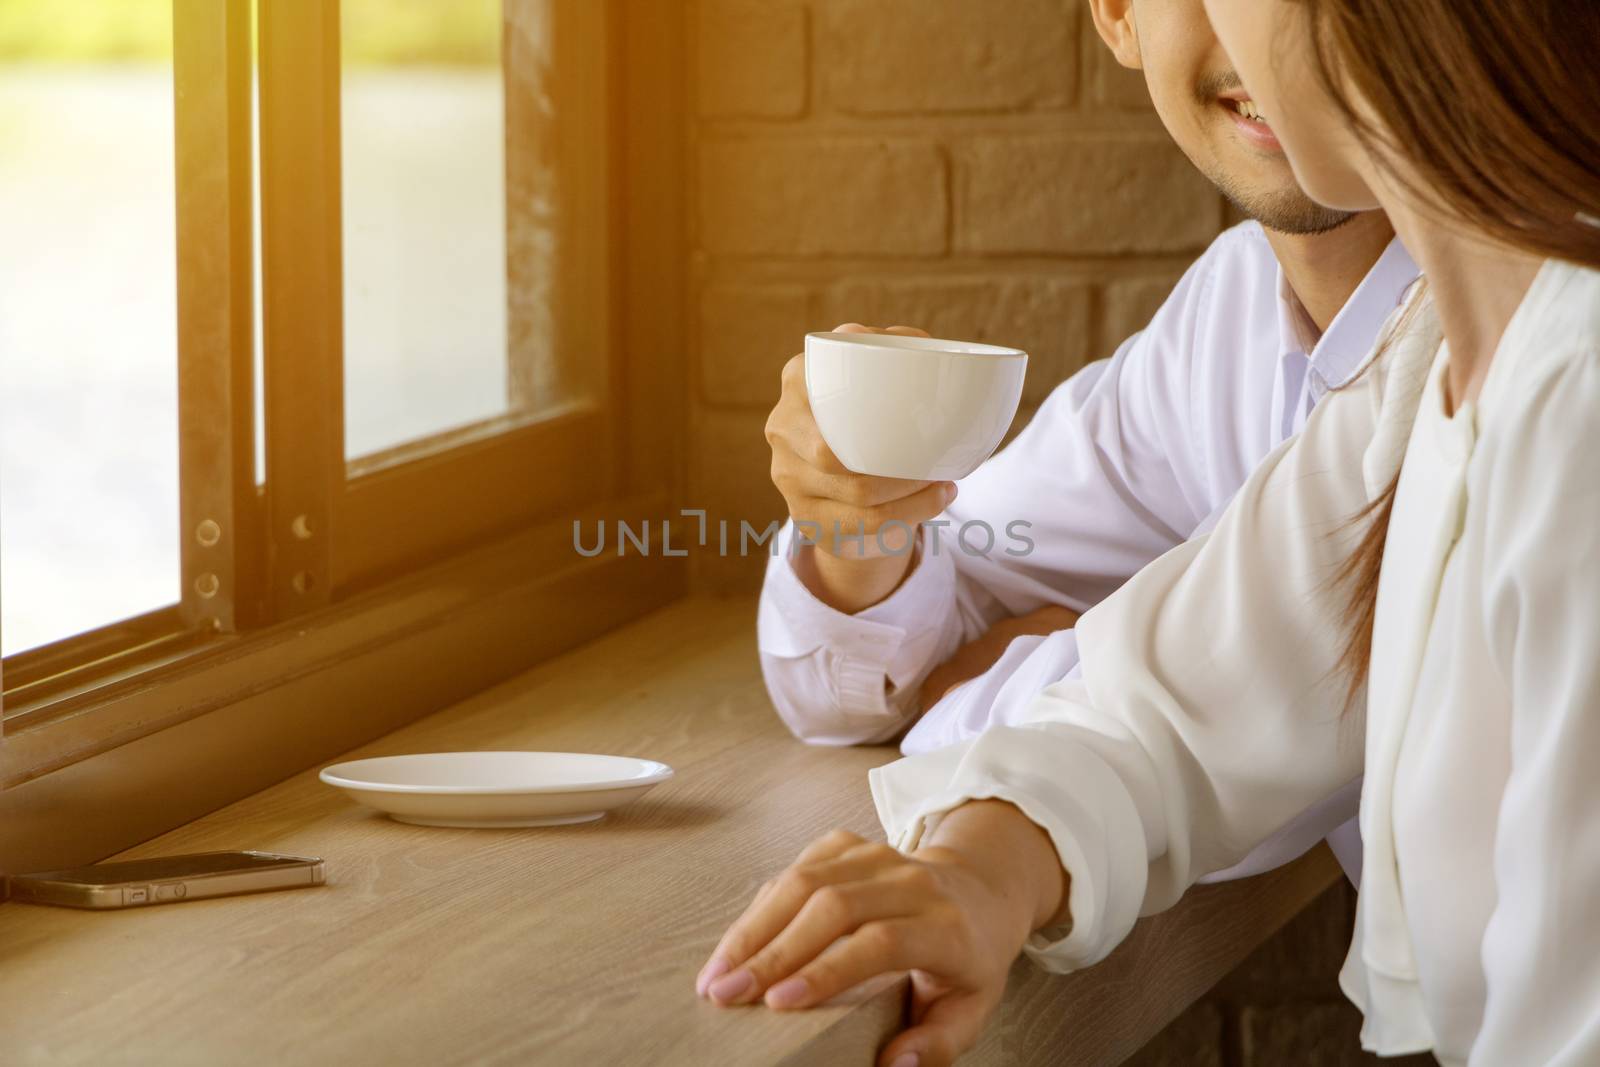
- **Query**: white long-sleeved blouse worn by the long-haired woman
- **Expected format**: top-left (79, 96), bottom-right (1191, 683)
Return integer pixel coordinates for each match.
top-left (870, 261), bottom-right (1600, 1067)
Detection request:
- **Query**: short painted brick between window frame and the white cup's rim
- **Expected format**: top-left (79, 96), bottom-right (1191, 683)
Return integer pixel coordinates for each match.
top-left (699, 285), bottom-right (812, 410)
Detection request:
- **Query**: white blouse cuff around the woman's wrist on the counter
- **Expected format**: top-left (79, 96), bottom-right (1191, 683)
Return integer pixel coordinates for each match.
top-left (867, 723), bottom-right (1149, 974)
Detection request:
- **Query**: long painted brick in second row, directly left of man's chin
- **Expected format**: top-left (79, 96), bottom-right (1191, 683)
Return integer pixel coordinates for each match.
top-left (955, 134), bottom-right (1222, 254)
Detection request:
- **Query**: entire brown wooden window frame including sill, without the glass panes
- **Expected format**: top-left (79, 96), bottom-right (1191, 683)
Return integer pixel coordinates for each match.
top-left (0, 0), bottom-right (688, 872)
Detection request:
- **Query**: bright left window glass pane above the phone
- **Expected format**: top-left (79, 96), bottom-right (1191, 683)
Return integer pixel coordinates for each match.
top-left (0, 0), bottom-right (179, 654)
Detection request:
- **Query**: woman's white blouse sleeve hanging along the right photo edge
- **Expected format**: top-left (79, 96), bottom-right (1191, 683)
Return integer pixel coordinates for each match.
top-left (1469, 350), bottom-right (1600, 1067)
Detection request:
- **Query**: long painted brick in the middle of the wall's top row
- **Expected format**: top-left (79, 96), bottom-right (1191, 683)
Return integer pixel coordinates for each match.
top-left (818, 0), bottom-right (1083, 114)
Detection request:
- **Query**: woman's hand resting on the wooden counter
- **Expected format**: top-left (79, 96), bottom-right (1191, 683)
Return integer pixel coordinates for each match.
top-left (694, 800), bottom-right (1064, 1067)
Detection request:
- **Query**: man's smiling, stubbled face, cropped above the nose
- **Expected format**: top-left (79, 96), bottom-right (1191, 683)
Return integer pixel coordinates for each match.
top-left (1133, 0), bottom-right (1350, 234)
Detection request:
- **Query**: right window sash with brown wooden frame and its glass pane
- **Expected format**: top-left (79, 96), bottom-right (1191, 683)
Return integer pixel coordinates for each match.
top-left (261, 0), bottom-right (616, 601)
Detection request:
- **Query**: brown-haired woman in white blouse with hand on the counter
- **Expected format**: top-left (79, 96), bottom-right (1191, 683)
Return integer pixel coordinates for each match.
top-left (698, 0), bottom-right (1600, 1067)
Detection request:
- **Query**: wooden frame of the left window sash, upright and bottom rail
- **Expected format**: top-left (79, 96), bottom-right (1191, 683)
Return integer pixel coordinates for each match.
top-left (0, 0), bottom-right (256, 742)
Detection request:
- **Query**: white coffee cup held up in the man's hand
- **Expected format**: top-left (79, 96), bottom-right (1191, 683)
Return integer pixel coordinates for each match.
top-left (805, 333), bottom-right (1027, 482)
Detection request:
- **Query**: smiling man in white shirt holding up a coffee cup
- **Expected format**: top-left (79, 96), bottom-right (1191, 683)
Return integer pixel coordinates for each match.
top-left (758, 0), bottom-right (1416, 881)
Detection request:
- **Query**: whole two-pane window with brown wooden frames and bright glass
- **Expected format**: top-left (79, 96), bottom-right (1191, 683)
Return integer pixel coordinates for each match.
top-left (0, 0), bottom-right (682, 789)
